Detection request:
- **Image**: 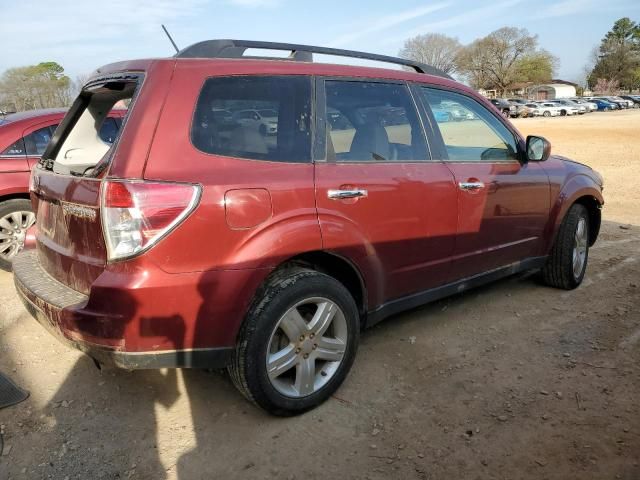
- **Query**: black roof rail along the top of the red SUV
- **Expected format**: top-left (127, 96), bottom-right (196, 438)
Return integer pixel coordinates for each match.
top-left (175, 40), bottom-right (451, 79)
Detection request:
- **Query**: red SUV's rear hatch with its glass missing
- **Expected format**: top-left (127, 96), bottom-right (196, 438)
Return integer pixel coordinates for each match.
top-left (30, 72), bottom-right (146, 294)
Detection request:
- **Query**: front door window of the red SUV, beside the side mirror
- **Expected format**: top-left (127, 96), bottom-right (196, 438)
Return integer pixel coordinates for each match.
top-left (420, 87), bottom-right (518, 161)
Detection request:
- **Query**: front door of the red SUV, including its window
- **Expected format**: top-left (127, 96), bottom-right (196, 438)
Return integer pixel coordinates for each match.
top-left (419, 87), bottom-right (550, 279)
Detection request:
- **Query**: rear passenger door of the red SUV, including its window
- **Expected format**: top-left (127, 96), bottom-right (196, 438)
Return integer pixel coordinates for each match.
top-left (315, 78), bottom-right (457, 307)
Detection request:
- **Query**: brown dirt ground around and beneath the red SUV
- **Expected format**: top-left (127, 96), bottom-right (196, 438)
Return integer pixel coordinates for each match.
top-left (0, 111), bottom-right (640, 480)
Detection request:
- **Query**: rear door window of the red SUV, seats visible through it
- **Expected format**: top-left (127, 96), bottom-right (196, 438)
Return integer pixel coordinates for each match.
top-left (325, 80), bottom-right (430, 162)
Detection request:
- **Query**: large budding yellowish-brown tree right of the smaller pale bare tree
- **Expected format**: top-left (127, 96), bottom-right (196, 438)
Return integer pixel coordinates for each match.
top-left (457, 27), bottom-right (557, 95)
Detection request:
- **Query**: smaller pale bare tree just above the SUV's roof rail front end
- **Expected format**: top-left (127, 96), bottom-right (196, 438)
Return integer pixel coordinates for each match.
top-left (399, 33), bottom-right (462, 73)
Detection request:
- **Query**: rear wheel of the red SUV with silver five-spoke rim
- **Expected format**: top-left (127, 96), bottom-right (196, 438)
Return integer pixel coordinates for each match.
top-left (229, 268), bottom-right (360, 416)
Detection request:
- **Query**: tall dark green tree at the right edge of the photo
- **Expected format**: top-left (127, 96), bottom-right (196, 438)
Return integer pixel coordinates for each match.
top-left (588, 17), bottom-right (640, 90)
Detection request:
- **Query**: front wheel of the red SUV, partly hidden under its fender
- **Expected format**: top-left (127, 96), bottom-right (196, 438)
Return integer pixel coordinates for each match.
top-left (542, 204), bottom-right (589, 290)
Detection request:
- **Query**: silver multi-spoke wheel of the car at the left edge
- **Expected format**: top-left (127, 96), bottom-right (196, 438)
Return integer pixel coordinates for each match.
top-left (0, 198), bottom-right (36, 271)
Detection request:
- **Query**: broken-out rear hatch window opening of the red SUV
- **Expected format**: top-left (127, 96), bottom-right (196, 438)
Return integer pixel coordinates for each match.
top-left (41, 74), bottom-right (142, 175)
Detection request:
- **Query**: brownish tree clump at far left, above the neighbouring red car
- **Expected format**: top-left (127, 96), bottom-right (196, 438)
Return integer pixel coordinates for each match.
top-left (0, 62), bottom-right (72, 111)
